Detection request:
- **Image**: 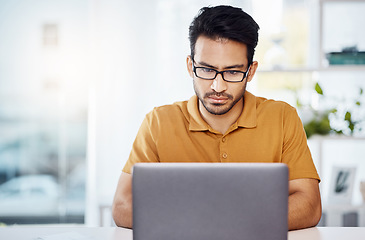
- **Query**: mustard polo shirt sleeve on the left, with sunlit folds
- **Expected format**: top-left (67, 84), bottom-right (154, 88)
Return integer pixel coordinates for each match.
top-left (123, 112), bottom-right (159, 173)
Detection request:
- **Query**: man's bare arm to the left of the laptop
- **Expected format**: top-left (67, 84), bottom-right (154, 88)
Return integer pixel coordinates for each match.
top-left (112, 172), bottom-right (132, 228)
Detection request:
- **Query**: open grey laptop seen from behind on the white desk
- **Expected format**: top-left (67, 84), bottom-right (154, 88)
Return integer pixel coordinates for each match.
top-left (132, 163), bottom-right (288, 240)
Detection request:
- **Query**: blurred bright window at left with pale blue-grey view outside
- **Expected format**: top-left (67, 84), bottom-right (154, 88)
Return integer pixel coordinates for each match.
top-left (0, 1), bottom-right (88, 224)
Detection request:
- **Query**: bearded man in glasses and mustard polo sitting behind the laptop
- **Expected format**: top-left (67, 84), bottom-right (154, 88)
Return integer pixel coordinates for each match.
top-left (113, 6), bottom-right (321, 230)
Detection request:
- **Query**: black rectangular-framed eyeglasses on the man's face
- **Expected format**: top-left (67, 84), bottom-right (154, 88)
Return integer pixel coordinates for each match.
top-left (193, 60), bottom-right (251, 82)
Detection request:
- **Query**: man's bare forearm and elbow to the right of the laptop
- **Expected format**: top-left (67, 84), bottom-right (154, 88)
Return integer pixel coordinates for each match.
top-left (288, 178), bottom-right (322, 230)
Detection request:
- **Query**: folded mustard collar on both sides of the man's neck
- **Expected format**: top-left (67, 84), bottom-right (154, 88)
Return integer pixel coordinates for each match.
top-left (187, 91), bottom-right (256, 131)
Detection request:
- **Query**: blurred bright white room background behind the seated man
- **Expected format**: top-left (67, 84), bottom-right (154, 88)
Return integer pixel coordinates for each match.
top-left (0, 0), bottom-right (365, 226)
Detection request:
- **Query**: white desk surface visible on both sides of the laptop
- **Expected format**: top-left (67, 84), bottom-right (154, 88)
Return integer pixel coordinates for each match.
top-left (0, 226), bottom-right (365, 240)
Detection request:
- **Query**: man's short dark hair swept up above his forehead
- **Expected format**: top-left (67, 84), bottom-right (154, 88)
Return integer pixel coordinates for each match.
top-left (189, 6), bottom-right (259, 63)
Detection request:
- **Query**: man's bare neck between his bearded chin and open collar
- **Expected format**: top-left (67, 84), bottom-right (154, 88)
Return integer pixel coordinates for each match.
top-left (199, 98), bottom-right (243, 134)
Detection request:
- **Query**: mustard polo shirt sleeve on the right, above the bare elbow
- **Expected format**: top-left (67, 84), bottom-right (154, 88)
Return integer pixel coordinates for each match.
top-left (282, 107), bottom-right (320, 181)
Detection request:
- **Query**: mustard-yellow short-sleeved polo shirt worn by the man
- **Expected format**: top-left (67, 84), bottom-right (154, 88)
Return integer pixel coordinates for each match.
top-left (123, 91), bottom-right (319, 180)
